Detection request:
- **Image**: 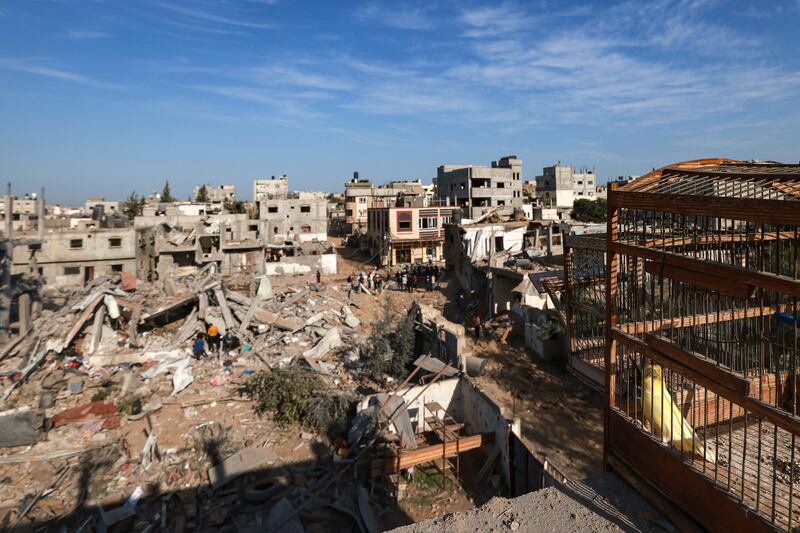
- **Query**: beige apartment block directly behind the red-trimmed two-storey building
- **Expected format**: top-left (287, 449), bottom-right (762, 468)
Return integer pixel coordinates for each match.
top-left (344, 172), bottom-right (424, 233)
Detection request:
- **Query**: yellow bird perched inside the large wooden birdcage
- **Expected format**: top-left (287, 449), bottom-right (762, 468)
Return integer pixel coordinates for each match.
top-left (642, 361), bottom-right (717, 463)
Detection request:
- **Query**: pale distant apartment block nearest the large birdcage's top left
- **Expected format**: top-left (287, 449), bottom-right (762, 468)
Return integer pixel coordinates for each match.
top-left (536, 162), bottom-right (605, 209)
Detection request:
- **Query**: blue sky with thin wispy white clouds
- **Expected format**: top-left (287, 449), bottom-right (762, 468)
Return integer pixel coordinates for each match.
top-left (0, 0), bottom-right (800, 203)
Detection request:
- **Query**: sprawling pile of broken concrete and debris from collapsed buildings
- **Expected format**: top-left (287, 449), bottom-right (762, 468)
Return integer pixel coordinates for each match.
top-left (0, 267), bottom-right (404, 531)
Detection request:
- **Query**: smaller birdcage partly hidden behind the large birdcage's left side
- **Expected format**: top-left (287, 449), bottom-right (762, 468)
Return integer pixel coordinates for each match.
top-left (564, 235), bottom-right (607, 389)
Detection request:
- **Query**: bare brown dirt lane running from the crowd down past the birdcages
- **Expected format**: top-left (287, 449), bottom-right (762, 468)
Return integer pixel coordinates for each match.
top-left (338, 240), bottom-right (603, 480)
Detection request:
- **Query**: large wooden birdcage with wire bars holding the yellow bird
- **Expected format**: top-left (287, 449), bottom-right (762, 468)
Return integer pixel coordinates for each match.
top-left (605, 160), bottom-right (800, 531)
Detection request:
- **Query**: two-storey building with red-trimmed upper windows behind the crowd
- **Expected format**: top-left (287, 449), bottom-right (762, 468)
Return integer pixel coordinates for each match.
top-left (366, 206), bottom-right (455, 266)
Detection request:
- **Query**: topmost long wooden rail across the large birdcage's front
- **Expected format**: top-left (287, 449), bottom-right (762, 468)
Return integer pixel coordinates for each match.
top-left (608, 190), bottom-right (800, 226)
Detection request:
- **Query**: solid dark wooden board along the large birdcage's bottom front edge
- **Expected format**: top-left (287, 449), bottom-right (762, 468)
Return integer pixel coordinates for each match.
top-left (607, 412), bottom-right (774, 532)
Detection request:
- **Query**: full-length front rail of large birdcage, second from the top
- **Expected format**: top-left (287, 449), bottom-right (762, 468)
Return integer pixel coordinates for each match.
top-left (609, 242), bottom-right (800, 297)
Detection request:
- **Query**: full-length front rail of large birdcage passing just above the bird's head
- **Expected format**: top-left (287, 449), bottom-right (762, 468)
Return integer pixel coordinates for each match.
top-left (606, 328), bottom-right (800, 435)
